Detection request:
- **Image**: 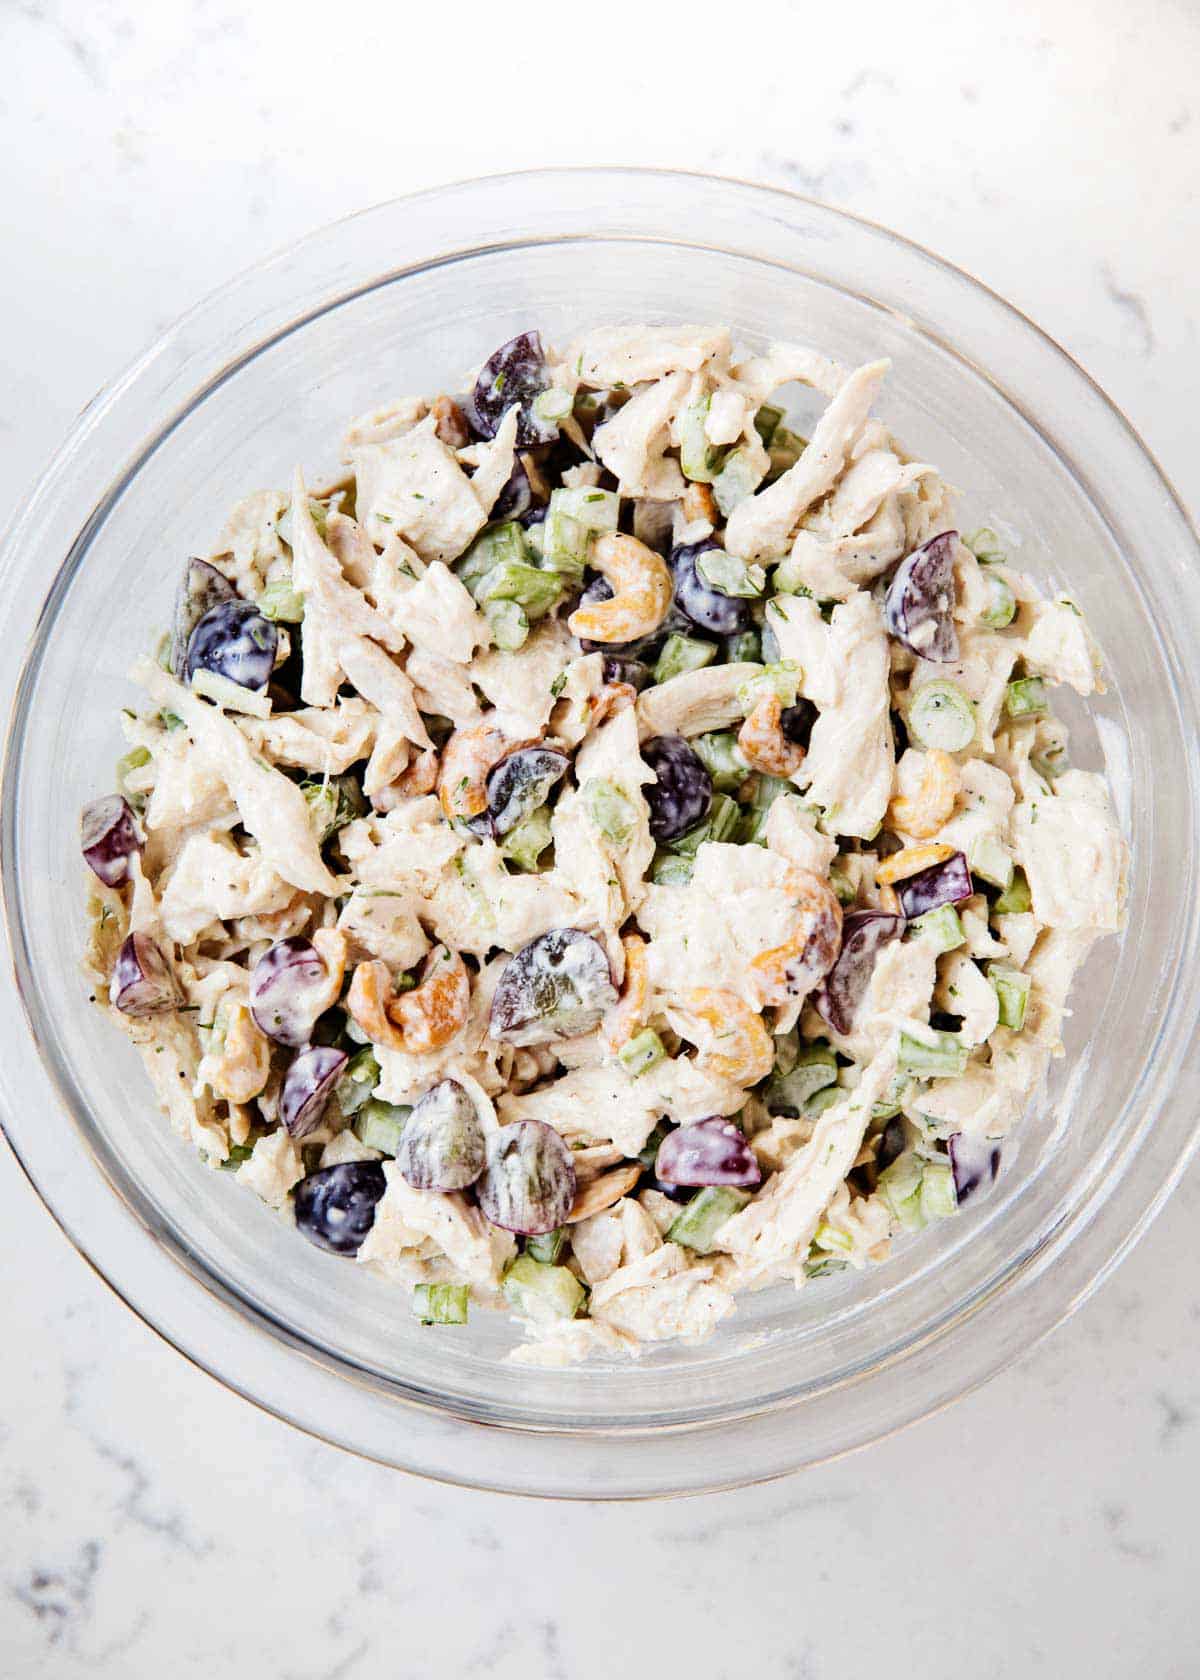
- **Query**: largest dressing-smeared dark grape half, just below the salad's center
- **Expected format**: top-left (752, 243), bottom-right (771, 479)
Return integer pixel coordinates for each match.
top-left (491, 927), bottom-right (617, 1045)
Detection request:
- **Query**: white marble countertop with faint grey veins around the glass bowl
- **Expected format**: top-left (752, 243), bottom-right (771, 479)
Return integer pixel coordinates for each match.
top-left (0, 0), bottom-right (1200, 1680)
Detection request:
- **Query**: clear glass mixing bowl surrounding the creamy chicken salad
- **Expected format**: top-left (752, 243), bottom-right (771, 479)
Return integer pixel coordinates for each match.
top-left (0, 170), bottom-right (1200, 1497)
